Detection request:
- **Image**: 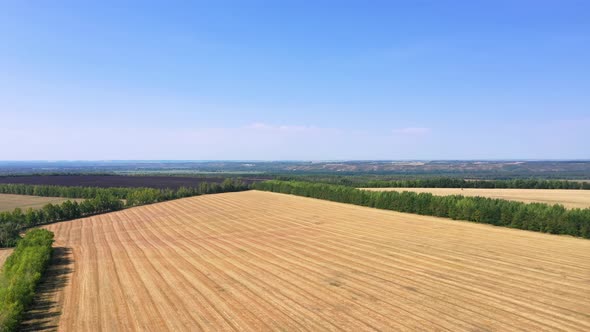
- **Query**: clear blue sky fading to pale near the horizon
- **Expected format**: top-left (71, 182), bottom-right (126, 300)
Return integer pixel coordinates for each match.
top-left (0, 0), bottom-right (590, 160)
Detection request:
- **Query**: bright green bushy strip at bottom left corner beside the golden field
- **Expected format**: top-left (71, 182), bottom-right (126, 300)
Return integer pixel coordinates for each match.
top-left (0, 229), bottom-right (53, 332)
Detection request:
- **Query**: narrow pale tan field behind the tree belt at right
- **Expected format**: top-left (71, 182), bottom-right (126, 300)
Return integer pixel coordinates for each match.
top-left (362, 188), bottom-right (590, 209)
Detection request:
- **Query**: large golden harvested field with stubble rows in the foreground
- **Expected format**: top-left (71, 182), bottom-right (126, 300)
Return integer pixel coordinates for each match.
top-left (41, 191), bottom-right (590, 331)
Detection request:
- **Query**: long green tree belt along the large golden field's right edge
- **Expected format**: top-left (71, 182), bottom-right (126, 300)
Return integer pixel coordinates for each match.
top-left (254, 180), bottom-right (590, 238)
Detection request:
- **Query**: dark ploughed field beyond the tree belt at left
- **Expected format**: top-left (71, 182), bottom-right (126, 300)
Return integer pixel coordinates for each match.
top-left (0, 175), bottom-right (264, 189)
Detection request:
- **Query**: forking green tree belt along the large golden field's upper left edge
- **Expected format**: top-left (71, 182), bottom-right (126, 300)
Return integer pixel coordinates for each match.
top-left (0, 179), bottom-right (249, 247)
